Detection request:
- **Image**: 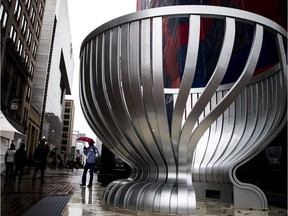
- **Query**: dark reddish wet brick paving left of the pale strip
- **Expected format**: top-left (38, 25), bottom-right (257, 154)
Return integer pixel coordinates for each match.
top-left (1, 169), bottom-right (82, 216)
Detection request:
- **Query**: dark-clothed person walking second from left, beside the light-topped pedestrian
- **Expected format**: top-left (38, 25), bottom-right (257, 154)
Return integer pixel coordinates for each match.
top-left (13, 143), bottom-right (27, 184)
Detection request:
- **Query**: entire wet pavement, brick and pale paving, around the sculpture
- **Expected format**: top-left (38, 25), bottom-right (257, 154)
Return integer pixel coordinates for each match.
top-left (1, 169), bottom-right (287, 216)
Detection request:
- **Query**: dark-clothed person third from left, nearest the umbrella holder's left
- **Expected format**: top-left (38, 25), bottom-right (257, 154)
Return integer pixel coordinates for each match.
top-left (32, 140), bottom-right (49, 184)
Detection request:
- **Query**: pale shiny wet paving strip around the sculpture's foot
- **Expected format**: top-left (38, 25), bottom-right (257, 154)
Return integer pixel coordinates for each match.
top-left (62, 183), bottom-right (287, 216)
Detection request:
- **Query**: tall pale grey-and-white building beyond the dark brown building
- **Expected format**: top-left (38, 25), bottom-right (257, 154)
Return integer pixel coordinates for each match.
top-left (31, 0), bottom-right (74, 150)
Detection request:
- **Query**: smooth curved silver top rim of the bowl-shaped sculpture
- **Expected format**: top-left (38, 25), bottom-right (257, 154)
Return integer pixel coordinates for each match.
top-left (80, 5), bottom-right (287, 53)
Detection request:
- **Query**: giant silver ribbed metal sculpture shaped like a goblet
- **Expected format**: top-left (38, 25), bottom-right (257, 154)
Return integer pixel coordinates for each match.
top-left (80, 6), bottom-right (287, 214)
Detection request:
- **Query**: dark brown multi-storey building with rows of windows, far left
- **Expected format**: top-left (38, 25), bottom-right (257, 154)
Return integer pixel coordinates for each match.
top-left (0, 0), bottom-right (46, 155)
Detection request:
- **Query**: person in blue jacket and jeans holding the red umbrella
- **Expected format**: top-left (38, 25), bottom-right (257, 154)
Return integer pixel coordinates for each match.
top-left (80, 142), bottom-right (99, 187)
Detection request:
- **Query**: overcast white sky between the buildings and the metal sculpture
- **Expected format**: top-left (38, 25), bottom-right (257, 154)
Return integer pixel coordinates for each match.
top-left (67, 0), bottom-right (136, 139)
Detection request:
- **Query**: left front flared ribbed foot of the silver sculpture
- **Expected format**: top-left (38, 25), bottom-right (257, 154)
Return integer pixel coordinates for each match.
top-left (103, 179), bottom-right (196, 214)
